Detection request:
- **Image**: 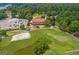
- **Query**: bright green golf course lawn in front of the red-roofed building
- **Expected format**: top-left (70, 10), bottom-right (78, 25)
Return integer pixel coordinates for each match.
top-left (1, 28), bottom-right (79, 54)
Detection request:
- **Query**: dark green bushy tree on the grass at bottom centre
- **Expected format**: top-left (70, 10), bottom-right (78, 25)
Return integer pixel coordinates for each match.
top-left (34, 41), bottom-right (49, 55)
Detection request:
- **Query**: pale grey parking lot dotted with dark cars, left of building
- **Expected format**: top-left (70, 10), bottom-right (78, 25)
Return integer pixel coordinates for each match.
top-left (0, 18), bottom-right (28, 29)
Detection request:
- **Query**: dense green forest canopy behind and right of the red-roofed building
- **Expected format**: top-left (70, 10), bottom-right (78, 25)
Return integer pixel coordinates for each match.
top-left (0, 3), bottom-right (79, 32)
